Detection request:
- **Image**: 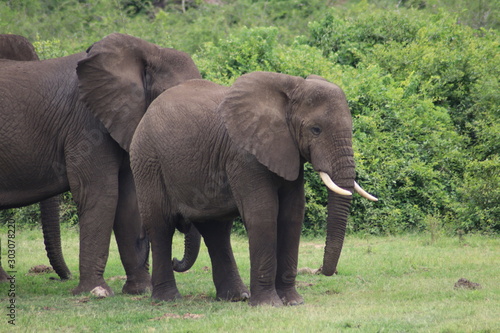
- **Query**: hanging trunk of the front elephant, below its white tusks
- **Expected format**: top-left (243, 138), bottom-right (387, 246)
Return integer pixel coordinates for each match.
top-left (321, 190), bottom-right (352, 276)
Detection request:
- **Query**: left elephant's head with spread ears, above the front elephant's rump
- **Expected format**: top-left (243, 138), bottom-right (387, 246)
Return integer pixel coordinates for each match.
top-left (77, 33), bottom-right (201, 151)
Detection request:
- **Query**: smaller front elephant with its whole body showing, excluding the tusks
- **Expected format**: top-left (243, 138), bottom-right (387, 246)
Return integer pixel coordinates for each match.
top-left (130, 72), bottom-right (355, 306)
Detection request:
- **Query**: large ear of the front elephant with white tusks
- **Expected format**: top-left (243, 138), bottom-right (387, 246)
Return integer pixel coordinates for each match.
top-left (219, 72), bottom-right (304, 181)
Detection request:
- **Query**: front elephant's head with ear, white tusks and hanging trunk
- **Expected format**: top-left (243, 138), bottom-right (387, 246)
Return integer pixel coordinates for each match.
top-left (219, 72), bottom-right (376, 275)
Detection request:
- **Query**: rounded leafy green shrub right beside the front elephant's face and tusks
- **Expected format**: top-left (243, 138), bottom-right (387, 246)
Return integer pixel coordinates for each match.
top-left (341, 65), bottom-right (463, 233)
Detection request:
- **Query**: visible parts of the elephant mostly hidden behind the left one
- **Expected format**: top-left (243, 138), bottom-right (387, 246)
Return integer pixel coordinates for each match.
top-left (0, 34), bottom-right (71, 282)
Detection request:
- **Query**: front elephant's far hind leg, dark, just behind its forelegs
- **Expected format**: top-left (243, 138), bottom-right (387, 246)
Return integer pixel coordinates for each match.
top-left (195, 220), bottom-right (250, 301)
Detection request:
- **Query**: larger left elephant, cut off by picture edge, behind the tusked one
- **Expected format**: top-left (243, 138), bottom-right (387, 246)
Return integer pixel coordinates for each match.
top-left (0, 34), bottom-right (200, 294)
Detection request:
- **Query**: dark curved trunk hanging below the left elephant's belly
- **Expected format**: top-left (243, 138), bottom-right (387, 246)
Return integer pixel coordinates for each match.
top-left (40, 196), bottom-right (71, 280)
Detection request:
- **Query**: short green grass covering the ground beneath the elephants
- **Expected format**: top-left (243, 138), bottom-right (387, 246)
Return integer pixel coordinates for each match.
top-left (0, 224), bottom-right (500, 332)
